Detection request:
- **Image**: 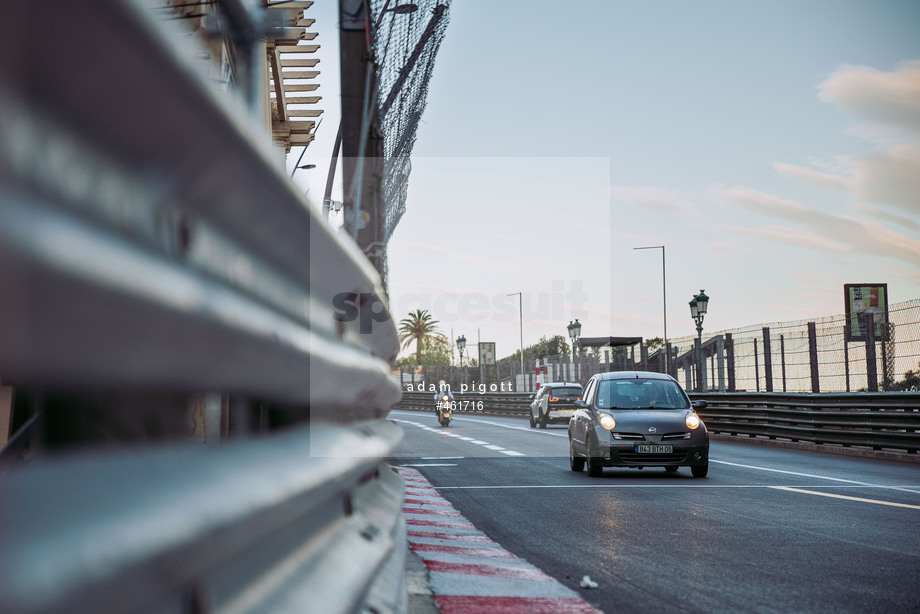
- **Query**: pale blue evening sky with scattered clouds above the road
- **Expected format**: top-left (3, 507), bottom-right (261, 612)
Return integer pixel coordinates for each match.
top-left (289, 0), bottom-right (920, 364)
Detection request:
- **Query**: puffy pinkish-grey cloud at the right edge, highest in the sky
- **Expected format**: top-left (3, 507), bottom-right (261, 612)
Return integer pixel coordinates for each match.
top-left (818, 60), bottom-right (920, 129)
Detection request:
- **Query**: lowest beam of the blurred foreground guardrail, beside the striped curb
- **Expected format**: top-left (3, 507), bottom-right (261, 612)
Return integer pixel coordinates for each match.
top-left (0, 421), bottom-right (406, 614)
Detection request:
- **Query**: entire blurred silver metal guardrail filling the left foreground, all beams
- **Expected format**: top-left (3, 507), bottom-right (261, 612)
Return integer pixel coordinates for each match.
top-left (0, 0), bottom-right (406, 613)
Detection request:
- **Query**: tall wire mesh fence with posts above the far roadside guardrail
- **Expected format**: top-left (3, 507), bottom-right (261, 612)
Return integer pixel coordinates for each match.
top-left (394, 299), bottom-right (920, 392)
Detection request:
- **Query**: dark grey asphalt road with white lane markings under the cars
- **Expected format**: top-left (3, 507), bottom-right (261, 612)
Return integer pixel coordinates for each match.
top-left (390, 411), bottom-right (920, 614)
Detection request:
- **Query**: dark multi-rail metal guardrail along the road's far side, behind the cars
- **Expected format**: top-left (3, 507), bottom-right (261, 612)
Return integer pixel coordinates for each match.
top-left (396, 392), bottom-right (920, 453)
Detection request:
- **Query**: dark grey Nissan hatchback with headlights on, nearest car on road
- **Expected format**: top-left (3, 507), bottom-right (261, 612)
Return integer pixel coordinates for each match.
top-left (569, 371), bottom-right (709, 478)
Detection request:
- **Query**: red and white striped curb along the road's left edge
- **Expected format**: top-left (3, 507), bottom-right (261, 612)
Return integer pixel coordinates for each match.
top-left (394, 467), bottom-right (599, 614)
